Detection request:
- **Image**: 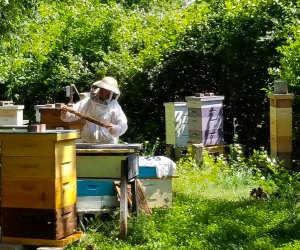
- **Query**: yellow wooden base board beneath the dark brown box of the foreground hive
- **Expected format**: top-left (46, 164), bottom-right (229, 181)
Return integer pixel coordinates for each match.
top-left (2, 231), bottom-right (84, 247)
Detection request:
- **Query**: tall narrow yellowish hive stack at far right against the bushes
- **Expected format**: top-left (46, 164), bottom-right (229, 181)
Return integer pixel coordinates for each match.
top-left (268, 94), bottom-right (294, 167)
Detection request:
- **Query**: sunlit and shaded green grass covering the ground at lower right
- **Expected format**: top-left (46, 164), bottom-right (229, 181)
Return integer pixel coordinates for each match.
top-left (67, 149), bottom-right (300, 250)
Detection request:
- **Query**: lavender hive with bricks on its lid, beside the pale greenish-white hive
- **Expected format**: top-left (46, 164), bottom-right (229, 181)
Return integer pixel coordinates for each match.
top-left (185, 95), bottom-right (224, 146)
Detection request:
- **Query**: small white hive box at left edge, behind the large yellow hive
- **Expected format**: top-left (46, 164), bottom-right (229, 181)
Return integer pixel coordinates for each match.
top-left (0, 105), bottom-right (24, 126)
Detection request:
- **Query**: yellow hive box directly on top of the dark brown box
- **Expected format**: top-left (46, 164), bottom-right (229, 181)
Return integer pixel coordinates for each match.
top-left (1, 175), bottom-right (76, 209)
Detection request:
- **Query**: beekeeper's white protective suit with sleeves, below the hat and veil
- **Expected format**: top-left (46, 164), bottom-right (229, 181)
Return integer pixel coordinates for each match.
top-left (61, 97), bottom-right (128, 143)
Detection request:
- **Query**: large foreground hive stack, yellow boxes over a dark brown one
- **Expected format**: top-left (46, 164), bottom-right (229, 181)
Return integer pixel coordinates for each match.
top-left (0, 131), bottom-right (79, 239)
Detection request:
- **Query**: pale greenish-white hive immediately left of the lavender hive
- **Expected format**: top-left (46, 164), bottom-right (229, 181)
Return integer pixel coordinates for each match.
top-left (164, 102), bottom-right (188, 147)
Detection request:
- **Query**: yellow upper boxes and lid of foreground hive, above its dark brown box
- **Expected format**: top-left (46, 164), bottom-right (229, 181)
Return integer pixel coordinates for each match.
top-left (0, 131), bottom-right (79, 209)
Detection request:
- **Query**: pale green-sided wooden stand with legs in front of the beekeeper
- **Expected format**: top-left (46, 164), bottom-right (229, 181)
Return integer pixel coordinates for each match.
top-left (76, 143), bottom-right (142, 239)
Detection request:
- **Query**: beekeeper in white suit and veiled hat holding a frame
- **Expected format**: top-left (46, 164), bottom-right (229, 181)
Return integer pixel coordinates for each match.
top-left (61, 76), bottom-right (128, 143)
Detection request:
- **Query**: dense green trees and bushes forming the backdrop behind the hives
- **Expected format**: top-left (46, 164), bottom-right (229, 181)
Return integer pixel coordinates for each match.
top-left (0, 0), bottom-right (299, 150)
